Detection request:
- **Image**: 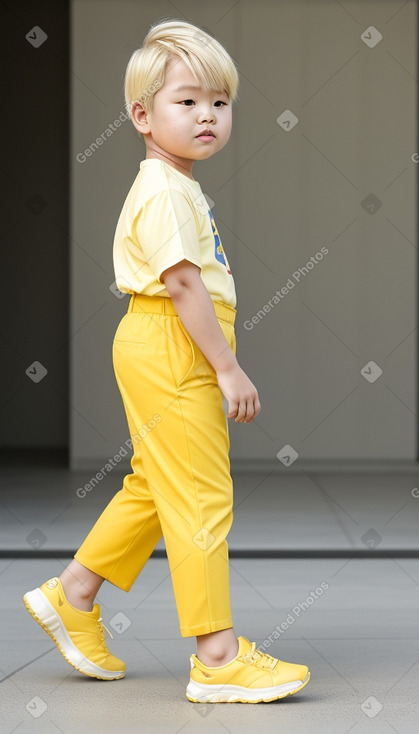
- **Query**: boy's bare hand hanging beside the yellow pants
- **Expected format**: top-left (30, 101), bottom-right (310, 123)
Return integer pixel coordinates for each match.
top-left (217, 364), bottom-right (260, 423)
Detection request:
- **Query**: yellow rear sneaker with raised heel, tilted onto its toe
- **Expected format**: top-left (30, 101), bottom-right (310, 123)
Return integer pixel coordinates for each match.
top-left (23, 577), bottom-right (126, 680)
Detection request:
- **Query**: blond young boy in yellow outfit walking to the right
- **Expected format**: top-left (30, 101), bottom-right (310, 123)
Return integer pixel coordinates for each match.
top-left (23, 20), bottom-right (310, 703)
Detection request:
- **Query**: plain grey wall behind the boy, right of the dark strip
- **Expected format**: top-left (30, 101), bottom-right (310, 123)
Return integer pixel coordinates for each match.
top-left (70, 0), bottom-right (418, 470)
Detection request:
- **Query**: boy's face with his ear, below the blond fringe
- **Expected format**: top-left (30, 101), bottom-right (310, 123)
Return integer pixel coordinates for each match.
top-left (134, 57), bottom-right (232, 171)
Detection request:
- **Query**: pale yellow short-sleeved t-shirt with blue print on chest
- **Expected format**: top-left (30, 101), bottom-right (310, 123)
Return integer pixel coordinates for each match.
top-left (113, 158), bottom-right (236, 308)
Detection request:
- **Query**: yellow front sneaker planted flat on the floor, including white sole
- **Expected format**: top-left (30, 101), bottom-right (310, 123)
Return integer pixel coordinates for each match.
top-left (186, 635), bottom-right (310, 703)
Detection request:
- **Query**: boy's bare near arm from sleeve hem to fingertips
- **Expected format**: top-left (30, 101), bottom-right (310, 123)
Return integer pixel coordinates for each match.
top-left (160, 260), bottom-right (260, 423)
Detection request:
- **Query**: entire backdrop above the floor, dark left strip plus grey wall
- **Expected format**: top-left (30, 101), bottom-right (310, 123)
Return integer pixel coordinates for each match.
top-left (0, 0), bottom-right (419, 471)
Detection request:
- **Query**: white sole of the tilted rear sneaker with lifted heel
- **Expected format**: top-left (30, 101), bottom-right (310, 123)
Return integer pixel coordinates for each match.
top-left (23, 588), bottom-right (125, 680)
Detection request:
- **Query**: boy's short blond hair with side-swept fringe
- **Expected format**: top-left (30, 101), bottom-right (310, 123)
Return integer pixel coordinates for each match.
top-left (124, 18), bottom-right (239, 116)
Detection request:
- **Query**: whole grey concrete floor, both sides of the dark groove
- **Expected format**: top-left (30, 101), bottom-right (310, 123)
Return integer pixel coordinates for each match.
top-left (0, 469), bottom-right (419, 734)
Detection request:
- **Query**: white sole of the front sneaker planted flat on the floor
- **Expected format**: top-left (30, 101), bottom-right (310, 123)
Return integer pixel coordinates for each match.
top-left (186, 671), bottom-right (310, 703)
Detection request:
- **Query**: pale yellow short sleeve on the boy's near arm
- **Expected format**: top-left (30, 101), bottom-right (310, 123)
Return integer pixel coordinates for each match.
top-left (135, 189), bottom-right (202, 285)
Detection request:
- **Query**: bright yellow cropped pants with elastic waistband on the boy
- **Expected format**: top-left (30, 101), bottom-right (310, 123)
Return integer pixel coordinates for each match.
top-left (74, 293), bottom-right (236, 637)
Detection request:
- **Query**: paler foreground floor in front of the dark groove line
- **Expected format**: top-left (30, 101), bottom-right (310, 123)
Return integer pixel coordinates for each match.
top-left (0, 558), bottom-right (419, 734)
